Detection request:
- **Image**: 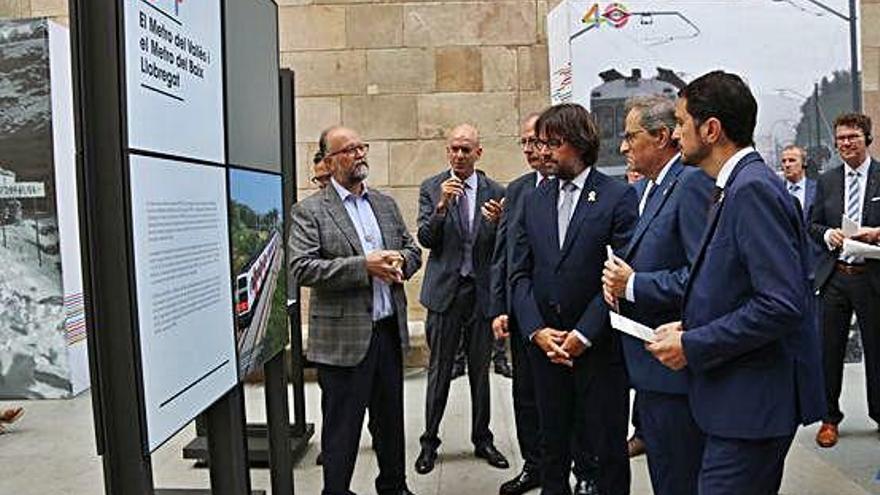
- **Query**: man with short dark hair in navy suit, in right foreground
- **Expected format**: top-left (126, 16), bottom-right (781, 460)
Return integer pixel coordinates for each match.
top-left (648, 71), bottom-right (824, 495)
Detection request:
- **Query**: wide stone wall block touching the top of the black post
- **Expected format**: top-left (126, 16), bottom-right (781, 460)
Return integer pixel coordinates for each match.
top-left (281, 50), bottom-right (367, 96)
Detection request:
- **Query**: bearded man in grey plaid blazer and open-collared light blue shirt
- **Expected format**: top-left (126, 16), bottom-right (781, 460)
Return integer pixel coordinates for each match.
top-left (289, 127), bottom-right (421, 495)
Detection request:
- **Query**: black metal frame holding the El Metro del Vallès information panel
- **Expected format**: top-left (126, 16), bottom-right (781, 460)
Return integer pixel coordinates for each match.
top-left (71, 0), bottom-right (272, 495)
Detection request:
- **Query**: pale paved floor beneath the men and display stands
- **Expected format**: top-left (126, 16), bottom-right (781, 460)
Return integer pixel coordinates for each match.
top-left (0, 365), bottom-right (880, 495)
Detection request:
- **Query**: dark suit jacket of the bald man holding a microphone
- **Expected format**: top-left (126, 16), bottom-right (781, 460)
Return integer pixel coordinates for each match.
top-left (418, 169), bottom-right (504, 317)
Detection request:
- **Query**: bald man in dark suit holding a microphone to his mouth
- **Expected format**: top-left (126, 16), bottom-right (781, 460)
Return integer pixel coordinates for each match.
top-left (416, 124), bottom-right (508, 474)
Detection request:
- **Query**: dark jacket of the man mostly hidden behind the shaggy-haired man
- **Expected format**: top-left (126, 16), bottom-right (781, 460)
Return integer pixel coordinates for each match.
top-left (490, 172), bottom-right (538, 318)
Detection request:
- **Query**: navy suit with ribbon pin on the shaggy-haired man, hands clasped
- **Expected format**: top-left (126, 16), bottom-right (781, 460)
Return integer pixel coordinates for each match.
top-left (511, 169), bottom-right (638, 495)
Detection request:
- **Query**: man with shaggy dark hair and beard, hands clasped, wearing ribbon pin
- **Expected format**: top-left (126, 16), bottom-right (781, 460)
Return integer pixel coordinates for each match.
top-left (511, 104), bottom-right (638, 495)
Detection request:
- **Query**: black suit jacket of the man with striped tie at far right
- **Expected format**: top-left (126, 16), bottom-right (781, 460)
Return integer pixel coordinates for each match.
top-left (810, 158), bottom-right (880, 292)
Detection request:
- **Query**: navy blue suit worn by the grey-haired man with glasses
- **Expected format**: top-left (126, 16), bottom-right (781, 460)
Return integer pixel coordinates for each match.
top-left (620, 161), bottom-right (713, 495)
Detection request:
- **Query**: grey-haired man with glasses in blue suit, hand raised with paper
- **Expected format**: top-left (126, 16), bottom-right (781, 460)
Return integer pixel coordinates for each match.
top-left (602, 96), bottom-right (713, 495)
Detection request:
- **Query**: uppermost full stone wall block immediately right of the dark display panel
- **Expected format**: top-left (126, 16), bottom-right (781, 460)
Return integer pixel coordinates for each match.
top-left (278, 5), bottom-right (345, 52)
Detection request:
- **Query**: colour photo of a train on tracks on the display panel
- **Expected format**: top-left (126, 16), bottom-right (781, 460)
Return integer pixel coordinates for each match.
top-left (229, 169), bottom-right (289, 379)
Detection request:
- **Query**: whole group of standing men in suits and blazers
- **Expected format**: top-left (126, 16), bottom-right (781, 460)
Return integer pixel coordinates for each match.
top-left (290, 71), bottom-right (880, 495)
